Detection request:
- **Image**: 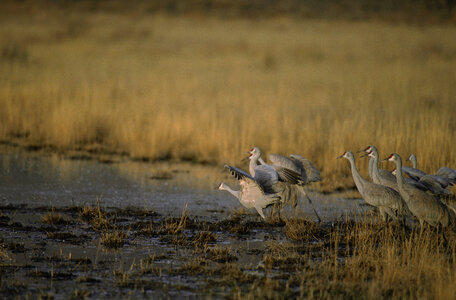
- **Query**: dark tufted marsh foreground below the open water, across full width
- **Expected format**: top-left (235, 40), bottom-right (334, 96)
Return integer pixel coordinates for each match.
top-left (0, 205), bottom-right (456, 299)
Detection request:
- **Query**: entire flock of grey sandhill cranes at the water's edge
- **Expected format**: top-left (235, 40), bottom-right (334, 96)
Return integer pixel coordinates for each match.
top-left (219, 145), bottom-right (456, 227)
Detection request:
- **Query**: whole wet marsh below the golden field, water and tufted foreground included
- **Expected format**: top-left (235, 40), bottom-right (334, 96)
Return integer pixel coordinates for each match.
top-left (0, 147), bottom-right (456, 299)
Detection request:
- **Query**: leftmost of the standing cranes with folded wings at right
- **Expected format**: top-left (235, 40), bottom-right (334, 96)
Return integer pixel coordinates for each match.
top-left (337, 151), bottom-right (410, 221)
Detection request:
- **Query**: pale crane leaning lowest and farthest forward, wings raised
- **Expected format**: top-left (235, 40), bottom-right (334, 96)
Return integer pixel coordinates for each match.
top-left (218, 165), bottom-right (280, 219)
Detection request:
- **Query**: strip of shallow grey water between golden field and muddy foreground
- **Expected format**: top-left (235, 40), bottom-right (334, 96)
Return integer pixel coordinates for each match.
top-left (0, 146), bottom-right (365, 221)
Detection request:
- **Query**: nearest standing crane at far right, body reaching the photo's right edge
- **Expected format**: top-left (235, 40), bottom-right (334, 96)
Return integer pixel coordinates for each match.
top-left (385, 153), bottom-right (455, 228)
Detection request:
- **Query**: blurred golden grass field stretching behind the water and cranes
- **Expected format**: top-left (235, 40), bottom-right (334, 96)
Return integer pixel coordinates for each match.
top-left (0, 5), bottom-right (456, 190)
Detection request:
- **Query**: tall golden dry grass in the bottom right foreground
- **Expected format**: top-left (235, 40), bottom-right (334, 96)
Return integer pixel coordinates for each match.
top-left (233, 215), bottom-right (456, 299)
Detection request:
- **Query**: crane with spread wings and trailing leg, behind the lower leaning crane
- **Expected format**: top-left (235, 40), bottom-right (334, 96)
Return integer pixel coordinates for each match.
top-left (249, 147), bottom-right (321, 222)
